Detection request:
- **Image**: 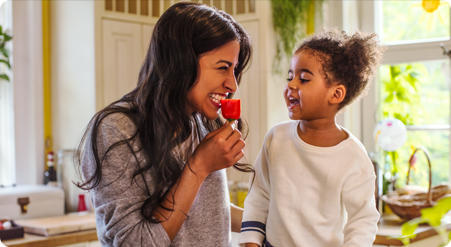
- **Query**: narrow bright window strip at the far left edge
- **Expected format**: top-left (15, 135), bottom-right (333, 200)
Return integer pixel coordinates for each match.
top-left (0, 0), bottom-right (16, 187)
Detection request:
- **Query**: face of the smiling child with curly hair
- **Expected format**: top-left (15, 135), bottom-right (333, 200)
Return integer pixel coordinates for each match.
top-left (284, 51), bottom-right (334, 120)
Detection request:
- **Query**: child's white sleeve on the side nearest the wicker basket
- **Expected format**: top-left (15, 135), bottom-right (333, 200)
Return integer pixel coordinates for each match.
top-left (341, 160), bottom-right (380, 247)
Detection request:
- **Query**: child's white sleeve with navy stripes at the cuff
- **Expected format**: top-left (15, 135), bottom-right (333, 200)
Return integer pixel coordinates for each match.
top-left (239, 138), bottom-right (270, 247)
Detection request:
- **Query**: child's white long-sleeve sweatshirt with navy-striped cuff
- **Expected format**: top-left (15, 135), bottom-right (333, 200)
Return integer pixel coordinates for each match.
top-left (239, 121), bottom-right (379, 247)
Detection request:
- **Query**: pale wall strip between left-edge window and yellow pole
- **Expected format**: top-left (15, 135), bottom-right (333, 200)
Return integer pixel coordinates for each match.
top-left (12, 1), bottom-right (44, 184)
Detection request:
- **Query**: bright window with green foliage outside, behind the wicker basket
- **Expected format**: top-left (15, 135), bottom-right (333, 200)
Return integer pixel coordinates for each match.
top-left (374, 1), bottom-right (451, 187)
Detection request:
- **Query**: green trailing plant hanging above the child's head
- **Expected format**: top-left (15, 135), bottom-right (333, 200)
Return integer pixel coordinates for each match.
top-left (271, 0), bottom-right (324, 73)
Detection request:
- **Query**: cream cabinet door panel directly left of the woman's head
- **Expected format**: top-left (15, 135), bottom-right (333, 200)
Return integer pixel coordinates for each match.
top-left (102, 20), bottom-right (143, 106)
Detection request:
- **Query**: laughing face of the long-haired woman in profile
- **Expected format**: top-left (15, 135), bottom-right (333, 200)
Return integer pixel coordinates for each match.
top-left (187, 41), bottom-right (240, 120)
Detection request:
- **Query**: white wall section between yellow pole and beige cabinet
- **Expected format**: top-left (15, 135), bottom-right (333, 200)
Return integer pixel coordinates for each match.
top-left (50, 1), bottom-right (96, 151)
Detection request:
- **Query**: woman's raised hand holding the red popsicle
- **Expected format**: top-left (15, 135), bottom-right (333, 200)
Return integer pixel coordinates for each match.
top-left (189, 120), bottom-right (245, 179)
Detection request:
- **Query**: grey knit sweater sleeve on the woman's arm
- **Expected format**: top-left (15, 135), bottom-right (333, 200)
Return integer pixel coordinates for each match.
top-left (82, 114), bottom-right (171, 247)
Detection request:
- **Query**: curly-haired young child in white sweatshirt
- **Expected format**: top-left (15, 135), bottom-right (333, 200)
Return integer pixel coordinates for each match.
top-left (239, 30), bottom-right (385, 247)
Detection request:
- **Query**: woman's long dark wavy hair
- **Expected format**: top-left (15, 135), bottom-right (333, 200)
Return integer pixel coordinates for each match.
top-left (76, 2), bottom-right (252, 223)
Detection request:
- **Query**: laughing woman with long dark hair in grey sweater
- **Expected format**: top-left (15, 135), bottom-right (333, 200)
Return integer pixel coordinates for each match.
top-left (78, 2), bottom-right (251, 246)
